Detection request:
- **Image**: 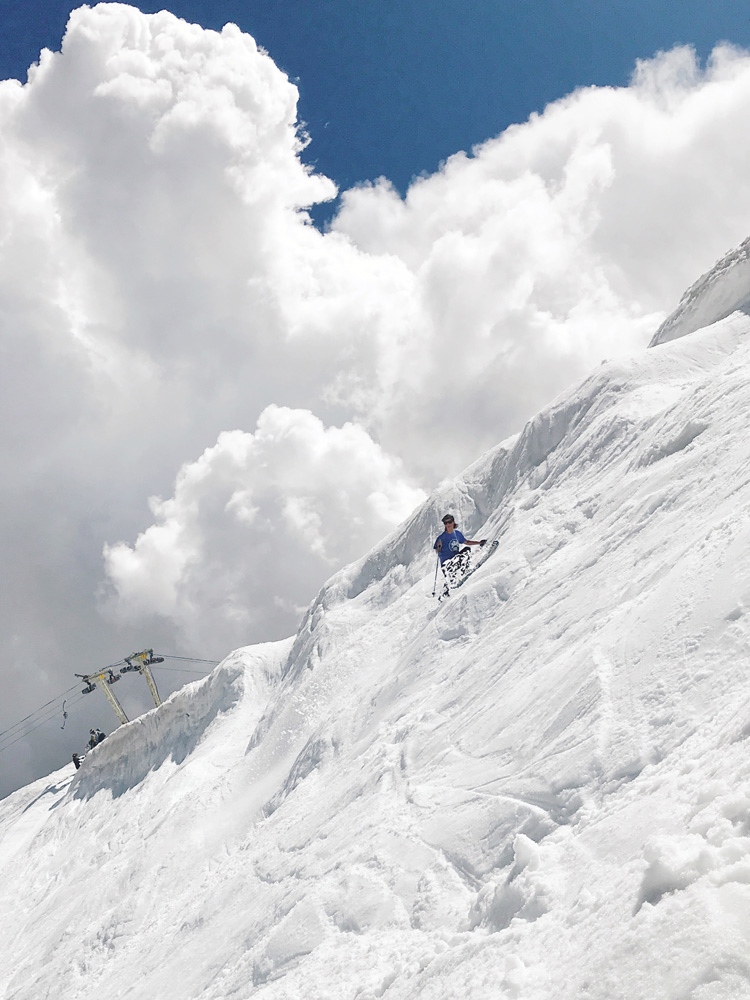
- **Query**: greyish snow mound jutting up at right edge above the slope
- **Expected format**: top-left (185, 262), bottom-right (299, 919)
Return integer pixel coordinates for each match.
top-left (649, 238), bottom-right (750, 347)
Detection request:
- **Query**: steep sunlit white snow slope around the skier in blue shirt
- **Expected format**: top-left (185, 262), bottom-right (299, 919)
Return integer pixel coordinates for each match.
top-left (0, 313), bottom-right (750, 1000)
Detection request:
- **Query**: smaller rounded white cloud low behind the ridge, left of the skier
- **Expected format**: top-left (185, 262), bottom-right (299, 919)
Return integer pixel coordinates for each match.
top-left (105, 406), bottom-right (425, 648)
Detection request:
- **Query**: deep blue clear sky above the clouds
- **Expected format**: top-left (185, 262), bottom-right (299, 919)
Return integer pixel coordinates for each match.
top-left (0, 0), bottom-right (750, 202)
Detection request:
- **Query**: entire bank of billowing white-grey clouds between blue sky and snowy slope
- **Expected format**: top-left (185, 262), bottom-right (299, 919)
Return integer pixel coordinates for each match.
top-left (0, 4), bottom-right (750, 792)
